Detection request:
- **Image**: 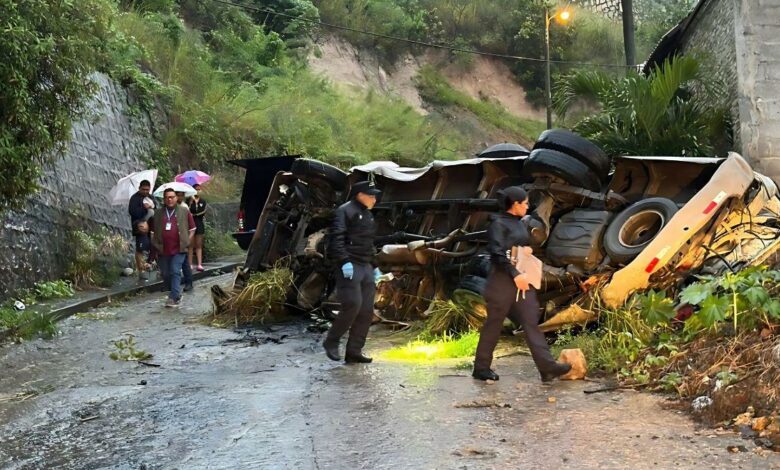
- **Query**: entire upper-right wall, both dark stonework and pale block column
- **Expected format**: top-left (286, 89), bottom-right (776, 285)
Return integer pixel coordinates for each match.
top-left (683, 0), bottom-right (780, 181)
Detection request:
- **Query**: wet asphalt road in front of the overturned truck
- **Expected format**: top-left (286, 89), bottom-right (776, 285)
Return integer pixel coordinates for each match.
top-left (0, 276), bottom-right (780, 469)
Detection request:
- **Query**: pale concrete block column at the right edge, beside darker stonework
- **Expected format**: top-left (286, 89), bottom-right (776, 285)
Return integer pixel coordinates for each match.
top-left (734, 0), bottom-right (780, 181)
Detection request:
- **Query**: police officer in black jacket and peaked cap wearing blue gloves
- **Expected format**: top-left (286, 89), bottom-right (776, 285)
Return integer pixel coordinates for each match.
top-left (322, 181), bottom-right (382, 364)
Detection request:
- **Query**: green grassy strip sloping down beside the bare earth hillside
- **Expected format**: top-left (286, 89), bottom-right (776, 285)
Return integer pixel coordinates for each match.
top-left (416, 65), bottom-right (545, 143)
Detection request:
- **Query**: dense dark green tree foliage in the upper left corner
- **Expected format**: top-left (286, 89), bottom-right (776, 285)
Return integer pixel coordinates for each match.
top-left (0, 0), bottom-right (112, 211)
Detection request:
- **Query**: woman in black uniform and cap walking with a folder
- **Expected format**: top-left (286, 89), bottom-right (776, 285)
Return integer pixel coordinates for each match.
top-left (472, 186), bottom-right (571, 382)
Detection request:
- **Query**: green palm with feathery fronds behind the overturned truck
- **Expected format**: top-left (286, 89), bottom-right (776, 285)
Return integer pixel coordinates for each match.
top-left (555, 56), bottom-right (731, 157)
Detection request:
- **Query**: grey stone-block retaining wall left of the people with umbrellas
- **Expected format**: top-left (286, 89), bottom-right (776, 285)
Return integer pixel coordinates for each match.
top-left (0, 75), bottom-right (160, 299)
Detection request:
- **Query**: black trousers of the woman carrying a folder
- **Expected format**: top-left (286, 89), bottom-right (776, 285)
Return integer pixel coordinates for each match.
top-left (474, 269), bottom-right (555, 372)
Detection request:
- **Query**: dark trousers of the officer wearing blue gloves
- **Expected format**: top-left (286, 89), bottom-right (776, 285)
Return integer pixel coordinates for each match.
top-left (326, 263), bottom-right (376, 354)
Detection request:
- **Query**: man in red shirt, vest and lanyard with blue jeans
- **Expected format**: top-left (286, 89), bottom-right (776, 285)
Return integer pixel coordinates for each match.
top-left (152, 189), bottom-right (195, 308)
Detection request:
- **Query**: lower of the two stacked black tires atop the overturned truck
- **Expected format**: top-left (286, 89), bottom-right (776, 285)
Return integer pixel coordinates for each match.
top-left (523, 149), bottom-right (601, 192)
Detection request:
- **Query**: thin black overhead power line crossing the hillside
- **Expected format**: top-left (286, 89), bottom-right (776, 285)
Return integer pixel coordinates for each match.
top-left (212, 0), bottom-right (630, 69)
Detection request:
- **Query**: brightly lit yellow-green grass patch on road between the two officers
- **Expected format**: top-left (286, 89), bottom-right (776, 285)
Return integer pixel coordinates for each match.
top-left (377, 331), bottom-right (479, 363)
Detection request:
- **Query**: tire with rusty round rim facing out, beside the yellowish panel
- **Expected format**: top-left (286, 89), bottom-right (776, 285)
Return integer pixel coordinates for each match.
top-left (604, 197), bottom-right (677, 264)
